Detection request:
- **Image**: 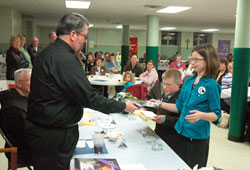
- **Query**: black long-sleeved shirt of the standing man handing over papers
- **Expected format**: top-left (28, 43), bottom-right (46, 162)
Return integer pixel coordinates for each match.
top-left (27, 38), bottom-right (126, 127)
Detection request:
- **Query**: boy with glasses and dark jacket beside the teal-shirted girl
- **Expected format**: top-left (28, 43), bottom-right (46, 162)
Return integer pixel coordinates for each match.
top-left (151, 69), bottom-right (182, 155)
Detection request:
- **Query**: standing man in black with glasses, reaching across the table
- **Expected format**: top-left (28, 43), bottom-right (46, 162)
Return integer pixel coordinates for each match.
top-left (25, 13), bottom-right (137, 170)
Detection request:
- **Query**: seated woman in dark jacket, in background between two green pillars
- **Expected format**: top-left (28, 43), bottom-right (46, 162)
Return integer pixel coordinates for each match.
top-left (123, 53), bottom-right (143, 77)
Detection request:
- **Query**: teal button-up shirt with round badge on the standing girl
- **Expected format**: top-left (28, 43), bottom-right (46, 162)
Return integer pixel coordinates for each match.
top-left (175, 74), bottom-right (221, 139)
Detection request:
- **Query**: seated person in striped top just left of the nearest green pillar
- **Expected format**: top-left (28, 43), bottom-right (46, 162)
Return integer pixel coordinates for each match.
top-left (221, 62), bottom-right (233, 113)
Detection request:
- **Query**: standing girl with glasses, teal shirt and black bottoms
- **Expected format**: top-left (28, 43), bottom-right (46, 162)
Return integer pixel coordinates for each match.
top-left (156, 45), bottom-right (221, 168)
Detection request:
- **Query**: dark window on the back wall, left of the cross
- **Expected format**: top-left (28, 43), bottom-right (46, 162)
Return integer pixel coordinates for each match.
top-left (161, 31), bottom-right (178, 45)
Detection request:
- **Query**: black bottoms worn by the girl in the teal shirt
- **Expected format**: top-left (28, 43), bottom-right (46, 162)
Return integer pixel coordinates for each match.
top-left (179, 136), bottom-right (209, 169)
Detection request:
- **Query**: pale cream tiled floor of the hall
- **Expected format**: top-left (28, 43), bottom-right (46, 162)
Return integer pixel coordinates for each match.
top-left (0, 122), bottom-right (250, 170)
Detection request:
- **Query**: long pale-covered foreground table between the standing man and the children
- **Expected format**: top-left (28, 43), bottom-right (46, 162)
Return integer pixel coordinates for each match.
top-left (71, 111), bottom-right (189, 170)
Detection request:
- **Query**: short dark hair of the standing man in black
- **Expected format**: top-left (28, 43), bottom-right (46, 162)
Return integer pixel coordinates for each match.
top-left (56, 13), bottom-right (89, 36)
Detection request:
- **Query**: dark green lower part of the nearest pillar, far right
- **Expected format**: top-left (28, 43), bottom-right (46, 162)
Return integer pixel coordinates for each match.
top-left (228, 48), bottom-right (250, 141)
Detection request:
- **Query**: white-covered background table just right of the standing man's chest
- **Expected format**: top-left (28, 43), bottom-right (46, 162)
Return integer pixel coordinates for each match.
top-left (88, 74), bottom-right (142, 86)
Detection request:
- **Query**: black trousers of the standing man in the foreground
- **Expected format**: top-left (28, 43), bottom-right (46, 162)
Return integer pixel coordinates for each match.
top-left (24, 121), bottom-right (79, 170)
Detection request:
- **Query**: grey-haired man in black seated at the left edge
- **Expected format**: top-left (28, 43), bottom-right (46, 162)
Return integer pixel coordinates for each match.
top-left (0, 69), bottom-right (31, 163)
